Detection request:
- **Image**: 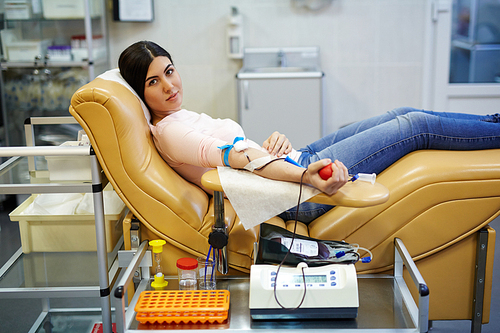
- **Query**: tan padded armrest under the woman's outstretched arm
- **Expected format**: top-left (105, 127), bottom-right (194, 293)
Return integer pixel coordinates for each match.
top-left (201, 169), bottom-right (389, 207)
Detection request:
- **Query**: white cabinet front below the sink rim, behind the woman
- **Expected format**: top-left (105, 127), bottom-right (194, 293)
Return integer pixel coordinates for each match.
top-left (238, 75), bottom-right (322, 149)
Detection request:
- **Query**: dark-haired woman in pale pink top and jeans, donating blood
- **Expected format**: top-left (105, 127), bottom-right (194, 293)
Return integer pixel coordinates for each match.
top-left (118, 41), bottom-right (500, 223)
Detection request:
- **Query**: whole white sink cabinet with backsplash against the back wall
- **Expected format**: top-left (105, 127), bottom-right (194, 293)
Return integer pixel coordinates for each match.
top-left (236, 47), bottom-right (323, 149)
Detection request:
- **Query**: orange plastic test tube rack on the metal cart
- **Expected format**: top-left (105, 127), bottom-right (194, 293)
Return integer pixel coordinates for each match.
top-left (134, 290), bottom-right (229, 324)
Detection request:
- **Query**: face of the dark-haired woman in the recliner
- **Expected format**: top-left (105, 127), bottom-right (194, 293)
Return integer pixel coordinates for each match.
top-left (144, 57), bottom-right (182, 117)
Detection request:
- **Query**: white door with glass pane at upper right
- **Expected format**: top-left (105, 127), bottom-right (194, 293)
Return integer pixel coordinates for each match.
top-left (423, 0), bottom-right (500, 114)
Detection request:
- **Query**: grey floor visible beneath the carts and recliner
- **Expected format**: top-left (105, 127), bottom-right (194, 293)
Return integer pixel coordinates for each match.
top-left (0, 195), bottom-right (500, 333)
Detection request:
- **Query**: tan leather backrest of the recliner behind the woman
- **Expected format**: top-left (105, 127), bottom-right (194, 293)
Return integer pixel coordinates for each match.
top-left (69, 77), bottom-right (209, 251)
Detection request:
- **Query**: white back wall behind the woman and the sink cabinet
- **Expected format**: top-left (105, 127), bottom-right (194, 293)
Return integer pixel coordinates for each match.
top-left (109, 0), bottom-right (426, 135)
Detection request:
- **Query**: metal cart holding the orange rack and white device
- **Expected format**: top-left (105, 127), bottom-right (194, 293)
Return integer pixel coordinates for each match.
top-left (114, 239), bottom-right (429, 333)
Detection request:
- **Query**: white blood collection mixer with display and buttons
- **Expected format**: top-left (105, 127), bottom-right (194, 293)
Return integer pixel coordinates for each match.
top-left (249, 263), bottom-right (359, 319)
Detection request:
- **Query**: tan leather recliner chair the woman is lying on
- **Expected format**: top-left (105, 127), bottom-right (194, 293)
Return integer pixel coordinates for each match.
top-left (70, 74), bottom-right (500, 323)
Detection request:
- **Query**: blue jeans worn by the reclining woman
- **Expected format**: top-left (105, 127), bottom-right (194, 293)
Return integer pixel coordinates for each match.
top-left (280, 108), bottom-right (500, 223)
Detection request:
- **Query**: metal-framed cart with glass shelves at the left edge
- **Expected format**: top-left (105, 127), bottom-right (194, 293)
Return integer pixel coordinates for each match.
top-left (0, 117), bottom-right (117, 333)
